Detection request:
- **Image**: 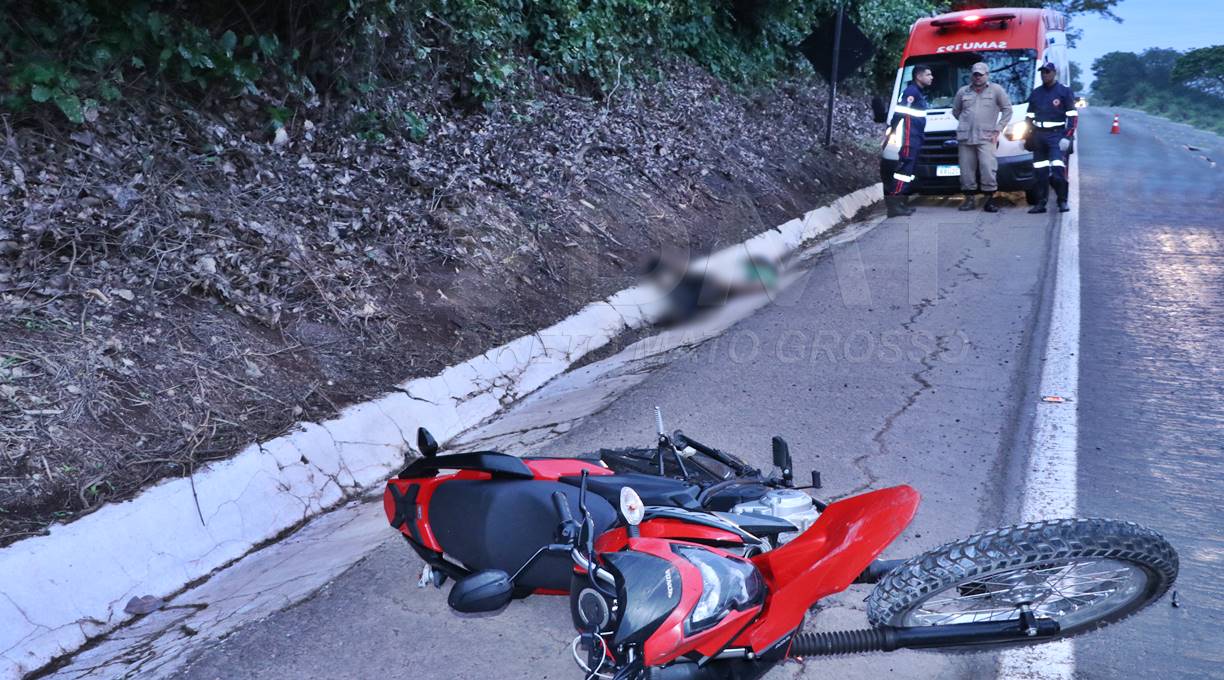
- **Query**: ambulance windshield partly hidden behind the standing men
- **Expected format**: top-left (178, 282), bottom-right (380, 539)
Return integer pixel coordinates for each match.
top-left (901, 50), bottom-right (1037, 109)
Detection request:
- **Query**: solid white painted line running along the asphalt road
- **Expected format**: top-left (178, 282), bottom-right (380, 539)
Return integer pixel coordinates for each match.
top-left (999, 149), bottom-right (1080, 680)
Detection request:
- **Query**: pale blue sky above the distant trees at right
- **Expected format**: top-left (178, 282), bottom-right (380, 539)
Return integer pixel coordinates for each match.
top-left (1071, 0), bottom-right (1224, 88)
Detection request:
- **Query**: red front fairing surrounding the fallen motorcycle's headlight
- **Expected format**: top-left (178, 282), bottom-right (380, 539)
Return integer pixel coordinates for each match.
top-left (629, 538), bottom-right (761, 667)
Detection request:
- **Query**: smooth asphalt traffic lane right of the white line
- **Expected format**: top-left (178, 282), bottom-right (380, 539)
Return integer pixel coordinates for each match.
top-left (1076, 109), bottom-right (1224, 679)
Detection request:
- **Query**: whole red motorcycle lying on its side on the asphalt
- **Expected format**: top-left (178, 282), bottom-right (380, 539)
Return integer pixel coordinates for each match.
top-left (384, 415), bottom-right (1177, 680)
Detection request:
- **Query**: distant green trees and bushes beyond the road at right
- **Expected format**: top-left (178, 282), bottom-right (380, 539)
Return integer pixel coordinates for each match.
top-left (1092, 45), bottom-right (1224, 135)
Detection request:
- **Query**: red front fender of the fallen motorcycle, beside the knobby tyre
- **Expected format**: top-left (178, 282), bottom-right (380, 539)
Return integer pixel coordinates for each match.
top-left (736, 486), bottom-right (920, 652)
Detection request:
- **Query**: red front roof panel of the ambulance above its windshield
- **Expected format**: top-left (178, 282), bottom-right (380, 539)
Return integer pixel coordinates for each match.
top-left (901, 9), bottom-right (1047, 65)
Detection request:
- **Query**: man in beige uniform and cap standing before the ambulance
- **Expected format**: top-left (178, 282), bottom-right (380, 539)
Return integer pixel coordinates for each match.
top-left (952, 61), bottom-right (1011, 213)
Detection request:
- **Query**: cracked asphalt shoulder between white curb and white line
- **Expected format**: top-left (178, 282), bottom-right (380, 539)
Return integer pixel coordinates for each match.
top-left (181, 168), bottom-right (1055, 680)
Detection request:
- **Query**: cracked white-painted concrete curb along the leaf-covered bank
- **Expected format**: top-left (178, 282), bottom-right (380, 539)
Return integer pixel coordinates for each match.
top-left (0, 185), bottom-right (881, 678)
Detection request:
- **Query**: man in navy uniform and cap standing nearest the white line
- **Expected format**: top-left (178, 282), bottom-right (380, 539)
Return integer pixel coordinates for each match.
top-left (1026, 61), bottom-right (1080, 213)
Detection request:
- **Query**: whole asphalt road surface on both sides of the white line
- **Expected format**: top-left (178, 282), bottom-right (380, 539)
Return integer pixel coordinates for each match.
top-left (170, 109), bottom-right (1224, 680)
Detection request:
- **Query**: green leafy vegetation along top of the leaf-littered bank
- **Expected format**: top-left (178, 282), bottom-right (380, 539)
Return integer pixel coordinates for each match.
top-left (0, 0), bottom-right (941, 125)
